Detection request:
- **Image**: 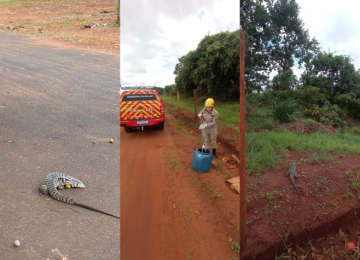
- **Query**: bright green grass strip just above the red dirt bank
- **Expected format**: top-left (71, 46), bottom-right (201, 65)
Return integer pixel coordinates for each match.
top-left (246, 129), bottom-right (360, 175)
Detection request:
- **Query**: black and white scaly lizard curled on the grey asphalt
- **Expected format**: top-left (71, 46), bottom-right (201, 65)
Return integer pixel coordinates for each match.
top-left (39, 172), bottom-right (120, 219)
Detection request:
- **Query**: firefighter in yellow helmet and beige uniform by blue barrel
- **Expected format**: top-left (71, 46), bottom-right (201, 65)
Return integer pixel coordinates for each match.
top-left (198, 98), bottom-right (219, 159)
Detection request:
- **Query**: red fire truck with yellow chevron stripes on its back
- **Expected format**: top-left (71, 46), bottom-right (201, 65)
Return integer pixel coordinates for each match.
top-left (120, 87), bottom-right (165, 133)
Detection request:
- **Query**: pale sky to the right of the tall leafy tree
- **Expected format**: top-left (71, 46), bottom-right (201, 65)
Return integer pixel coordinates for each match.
top-left (282, 0), bottom-right (360, 80)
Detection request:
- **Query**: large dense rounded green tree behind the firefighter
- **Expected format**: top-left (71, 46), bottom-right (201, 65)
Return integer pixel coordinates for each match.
top-left (174, 30), bottom-right (240, 97)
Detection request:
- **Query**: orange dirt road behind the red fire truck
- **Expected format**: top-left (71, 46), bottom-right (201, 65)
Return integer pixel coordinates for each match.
top-left (120, 113), bottom-right (239, 260)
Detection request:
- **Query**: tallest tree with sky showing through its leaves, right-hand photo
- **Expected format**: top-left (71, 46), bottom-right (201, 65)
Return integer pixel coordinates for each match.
top-left (240, 0), bottom-right (320, 90)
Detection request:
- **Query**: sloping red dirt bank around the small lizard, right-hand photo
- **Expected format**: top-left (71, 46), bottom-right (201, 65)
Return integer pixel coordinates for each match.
top-left (241, 151), bottom-right (360, 259)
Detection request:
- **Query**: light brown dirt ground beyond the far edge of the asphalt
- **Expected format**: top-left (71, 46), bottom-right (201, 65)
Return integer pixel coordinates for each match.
top-left (0, 0), bottom-right (120, 56)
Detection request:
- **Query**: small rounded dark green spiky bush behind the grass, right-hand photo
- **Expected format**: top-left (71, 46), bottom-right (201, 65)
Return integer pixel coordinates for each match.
top-left (272, 99), bottom-right (300, 123)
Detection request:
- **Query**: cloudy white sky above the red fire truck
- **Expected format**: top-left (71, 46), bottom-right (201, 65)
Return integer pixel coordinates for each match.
top-left (120, 0), bottom-right (240, 87)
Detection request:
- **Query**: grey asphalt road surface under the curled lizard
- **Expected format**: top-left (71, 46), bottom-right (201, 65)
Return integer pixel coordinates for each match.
top-left (0, 31), bottom-right (120, 260)
